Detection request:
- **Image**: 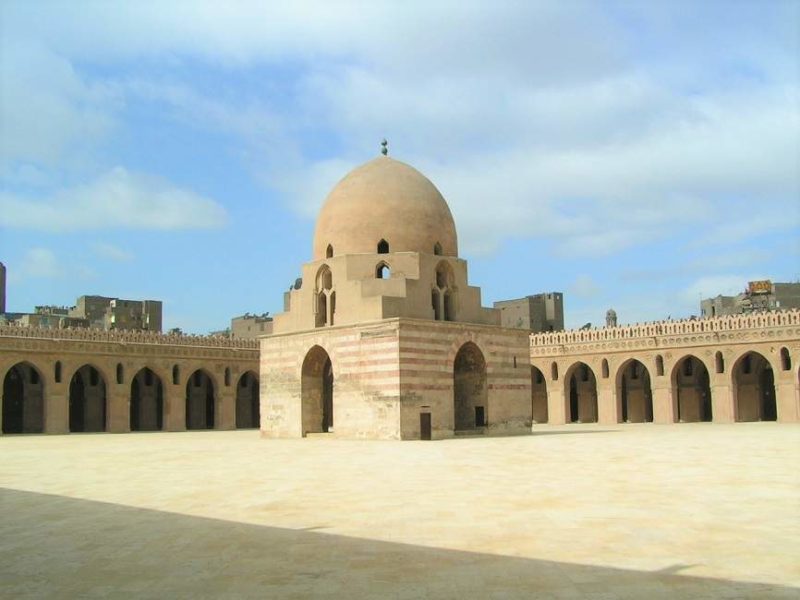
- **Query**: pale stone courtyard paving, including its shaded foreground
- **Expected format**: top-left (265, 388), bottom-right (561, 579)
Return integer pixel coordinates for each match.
top-left (0, 423), bottom-right (800, 600)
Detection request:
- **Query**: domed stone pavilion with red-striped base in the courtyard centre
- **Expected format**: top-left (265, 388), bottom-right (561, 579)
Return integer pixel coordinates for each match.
top-left (261, 156), bottom-right (531, 439)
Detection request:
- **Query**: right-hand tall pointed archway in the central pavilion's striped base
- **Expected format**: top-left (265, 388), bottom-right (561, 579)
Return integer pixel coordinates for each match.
top-left (453, 342), bottom-right (489, 431)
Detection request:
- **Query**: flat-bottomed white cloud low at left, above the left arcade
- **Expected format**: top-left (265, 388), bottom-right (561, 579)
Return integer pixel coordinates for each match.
top-left (0, 167), bottom-right (227, 231)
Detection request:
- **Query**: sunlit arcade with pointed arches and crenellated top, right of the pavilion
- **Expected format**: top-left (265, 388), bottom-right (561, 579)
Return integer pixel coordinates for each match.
top-left (531, 311), bottom-right (800, 424)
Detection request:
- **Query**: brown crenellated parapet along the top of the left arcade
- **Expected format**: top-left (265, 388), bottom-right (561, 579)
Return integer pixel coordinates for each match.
top-left (0, 325), bottom-right (258, 350)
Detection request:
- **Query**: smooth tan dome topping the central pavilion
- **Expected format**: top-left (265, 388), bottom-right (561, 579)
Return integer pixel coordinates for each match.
top-left (314, 156), bottom-right (458, 260)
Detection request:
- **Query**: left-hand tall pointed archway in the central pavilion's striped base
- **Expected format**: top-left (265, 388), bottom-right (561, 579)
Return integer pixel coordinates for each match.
top-left (300, 346), bottom-right (333, 435)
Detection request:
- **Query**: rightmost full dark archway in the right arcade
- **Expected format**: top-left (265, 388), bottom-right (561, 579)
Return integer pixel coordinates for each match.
top-left (733, 352), bottom-right (778, 421)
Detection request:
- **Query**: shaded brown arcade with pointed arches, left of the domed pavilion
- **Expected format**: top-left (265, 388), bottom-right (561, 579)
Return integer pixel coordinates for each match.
top-left (0, 327), bottom-right (259, 433)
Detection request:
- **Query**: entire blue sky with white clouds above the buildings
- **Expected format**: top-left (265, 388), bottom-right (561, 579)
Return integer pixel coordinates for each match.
top-left (0, 0), bottom-right (800, 333)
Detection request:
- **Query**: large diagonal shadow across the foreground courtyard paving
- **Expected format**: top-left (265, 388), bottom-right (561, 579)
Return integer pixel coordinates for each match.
top-left (0, 489), bottom-right (797, 600)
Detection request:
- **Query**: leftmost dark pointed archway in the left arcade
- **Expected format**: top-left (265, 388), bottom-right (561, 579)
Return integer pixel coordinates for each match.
top-left (2, 362), bottom-right (44, 433)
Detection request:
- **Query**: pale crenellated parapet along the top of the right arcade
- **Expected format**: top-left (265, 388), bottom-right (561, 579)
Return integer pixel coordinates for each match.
top-left (531, 309), bottom-right (800, 346)
